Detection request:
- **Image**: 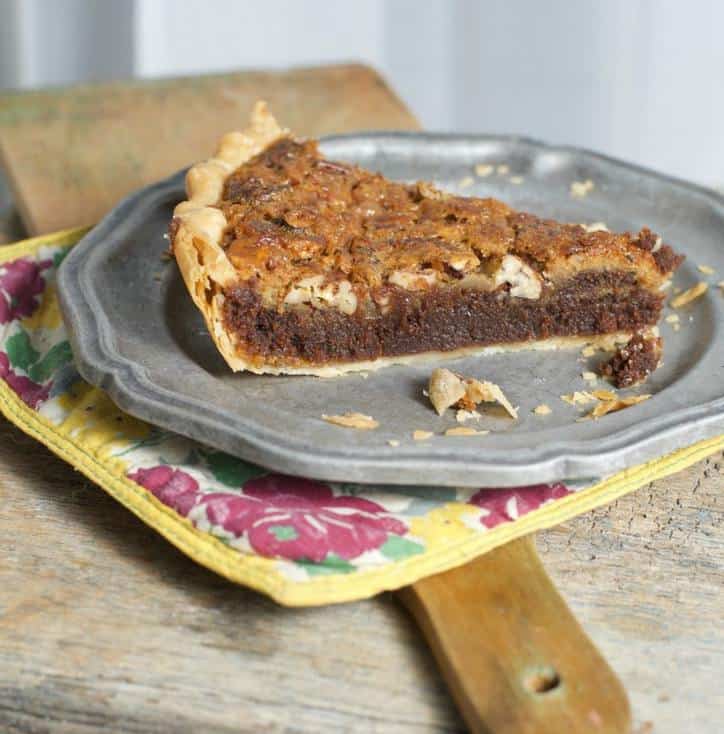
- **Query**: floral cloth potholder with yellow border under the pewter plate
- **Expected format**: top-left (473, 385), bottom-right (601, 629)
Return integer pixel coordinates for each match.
top-left (0, 230), bottom-right (724, 605)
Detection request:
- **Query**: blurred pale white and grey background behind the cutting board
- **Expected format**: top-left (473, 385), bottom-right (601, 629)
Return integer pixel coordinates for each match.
top-left (0, 0), bottom-right (724, 183)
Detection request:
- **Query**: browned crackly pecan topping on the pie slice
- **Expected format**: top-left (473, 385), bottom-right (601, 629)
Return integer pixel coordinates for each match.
top-left (219, 138), bottom-right (675, 301)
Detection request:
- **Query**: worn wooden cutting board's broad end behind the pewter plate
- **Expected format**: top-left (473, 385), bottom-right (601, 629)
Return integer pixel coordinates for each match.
top-left (0, 64), bottom-right (417, 235)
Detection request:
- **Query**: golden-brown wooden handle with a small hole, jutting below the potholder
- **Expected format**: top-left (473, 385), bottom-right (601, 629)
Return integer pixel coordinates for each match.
top-left (400, 536), bottom-right (631, 734)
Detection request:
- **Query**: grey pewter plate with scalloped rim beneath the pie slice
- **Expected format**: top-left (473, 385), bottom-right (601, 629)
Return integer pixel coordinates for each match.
top-left (59, 133), bottom-right (724, 486)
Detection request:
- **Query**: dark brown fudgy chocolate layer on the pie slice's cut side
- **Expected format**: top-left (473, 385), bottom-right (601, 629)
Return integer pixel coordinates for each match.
top-left (224, 271), bottom-right (663, 365)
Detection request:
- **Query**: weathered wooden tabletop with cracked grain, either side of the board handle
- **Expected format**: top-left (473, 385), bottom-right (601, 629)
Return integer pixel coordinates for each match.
top-left (0, 423), bottom-right (724, 734)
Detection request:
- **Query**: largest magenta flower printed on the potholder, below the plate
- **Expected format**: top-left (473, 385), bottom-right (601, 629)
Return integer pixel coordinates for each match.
top-left (202, 474), bottom-right (406, 562)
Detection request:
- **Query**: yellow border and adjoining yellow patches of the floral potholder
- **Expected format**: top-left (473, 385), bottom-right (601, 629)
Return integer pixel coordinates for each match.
top-left (0, 230), bottom-right (724, 606)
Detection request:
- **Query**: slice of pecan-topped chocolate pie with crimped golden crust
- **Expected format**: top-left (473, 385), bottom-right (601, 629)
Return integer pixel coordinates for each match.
top-left (170, 102), bottom-right (683, 376)
